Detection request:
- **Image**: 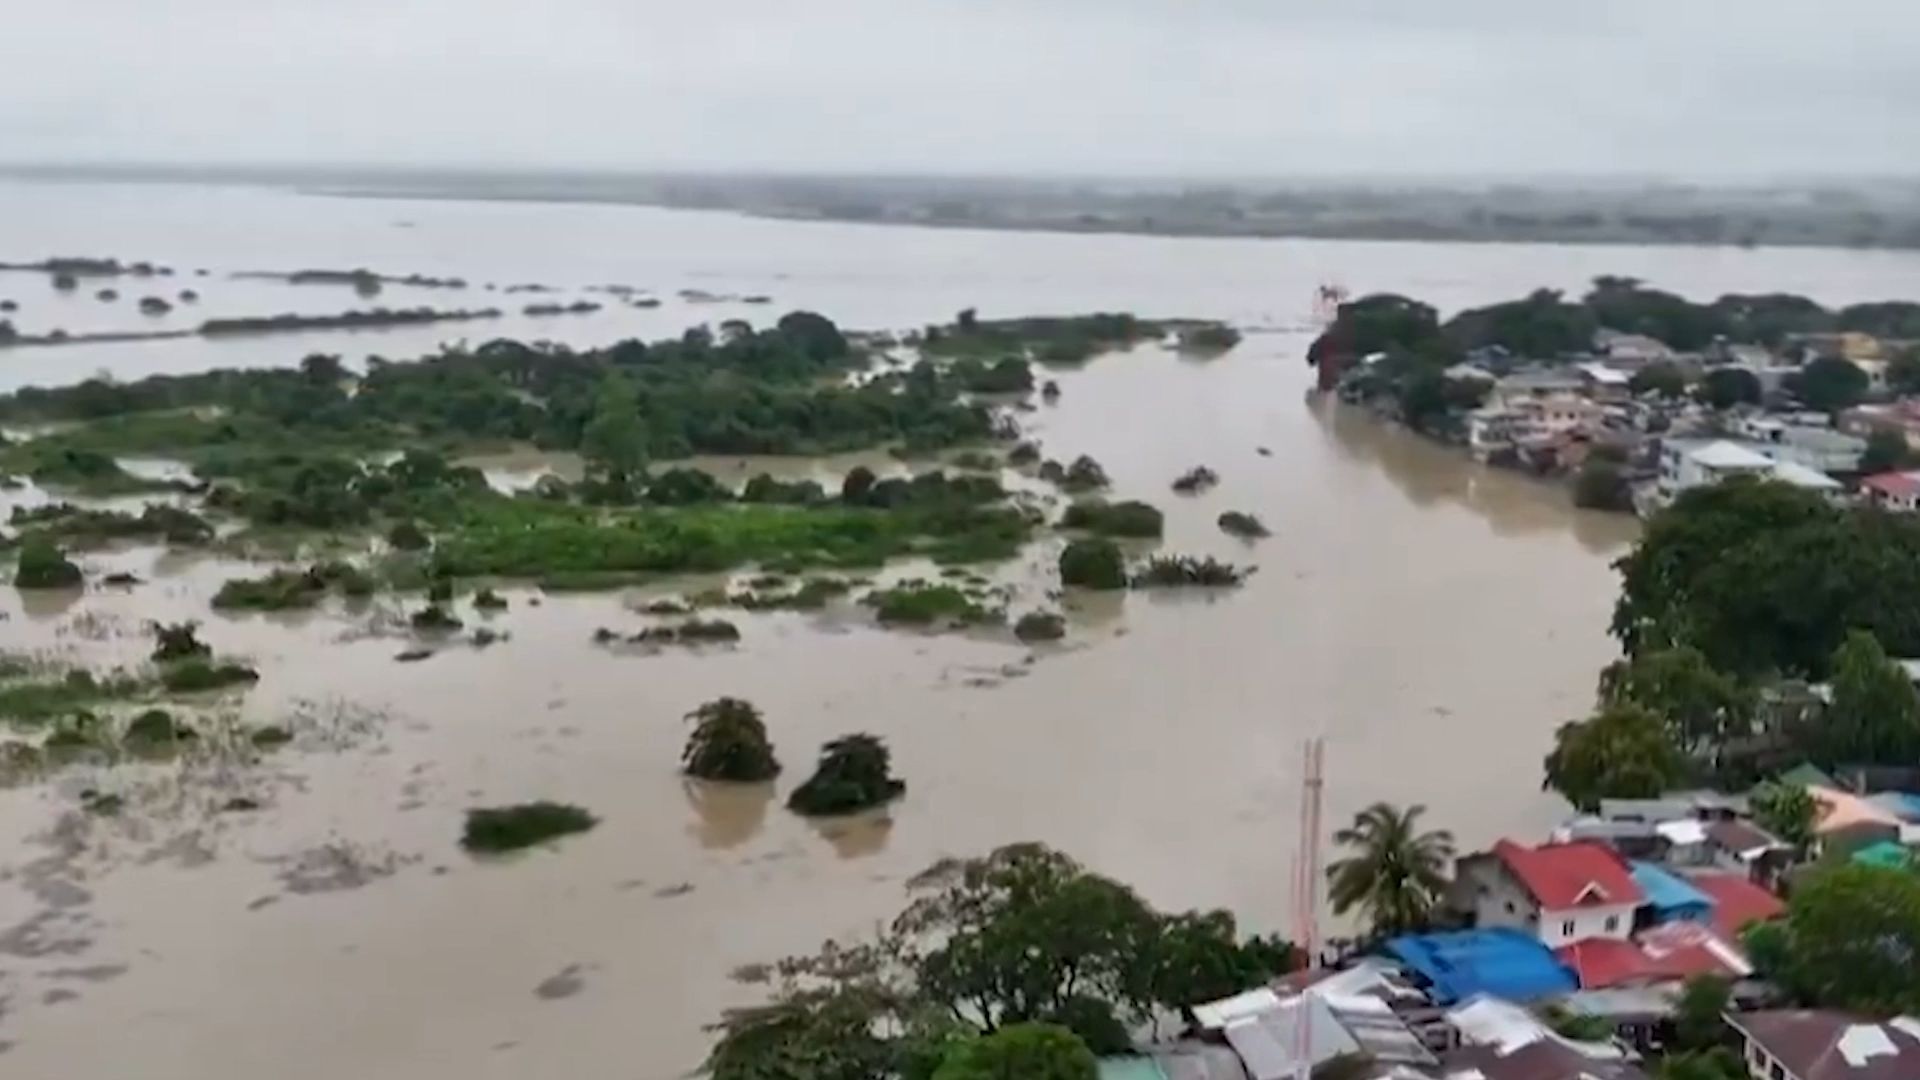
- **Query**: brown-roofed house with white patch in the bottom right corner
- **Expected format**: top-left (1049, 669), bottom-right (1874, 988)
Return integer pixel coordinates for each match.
top-left (1726, 1009), bottom-right (1920, 1080)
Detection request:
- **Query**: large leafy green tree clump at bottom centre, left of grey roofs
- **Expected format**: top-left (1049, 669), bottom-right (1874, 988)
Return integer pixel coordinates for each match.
top-left (707, 844), bottom-right (1296, 1080)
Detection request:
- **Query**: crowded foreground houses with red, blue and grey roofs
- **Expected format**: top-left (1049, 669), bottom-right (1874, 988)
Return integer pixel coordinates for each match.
top-left (1102, 767), bottom-right (1920, 1080)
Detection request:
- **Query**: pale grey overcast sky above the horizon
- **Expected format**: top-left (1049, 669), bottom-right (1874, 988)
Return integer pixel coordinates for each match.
top-left (0, 0), bottom-right (1920, 177)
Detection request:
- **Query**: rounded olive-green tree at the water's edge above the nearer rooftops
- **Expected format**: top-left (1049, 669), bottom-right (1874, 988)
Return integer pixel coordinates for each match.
top-left (1542, 703), bottom-right (1684, 811)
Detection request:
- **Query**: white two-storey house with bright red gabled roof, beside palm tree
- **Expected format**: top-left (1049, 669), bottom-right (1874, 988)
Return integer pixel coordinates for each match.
top-left (1455, 840), bottom-right (1645, 949)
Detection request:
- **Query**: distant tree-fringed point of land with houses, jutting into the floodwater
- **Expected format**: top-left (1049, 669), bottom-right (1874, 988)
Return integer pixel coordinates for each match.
top-left (1311, 279), bottom-right (1920, 513)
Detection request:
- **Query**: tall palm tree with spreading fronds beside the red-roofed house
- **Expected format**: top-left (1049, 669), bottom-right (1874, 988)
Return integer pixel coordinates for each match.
top-left (1327, 803), bottom-right (1453, 938)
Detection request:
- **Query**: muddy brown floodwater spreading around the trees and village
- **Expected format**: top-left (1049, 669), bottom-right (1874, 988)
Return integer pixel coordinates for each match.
top-left (0, 184), bottom-right (1920, 1080)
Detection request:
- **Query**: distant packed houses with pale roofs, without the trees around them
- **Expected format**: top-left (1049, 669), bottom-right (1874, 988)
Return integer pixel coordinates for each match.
top-left (1413, 331), bottom-right (1920, 515)
